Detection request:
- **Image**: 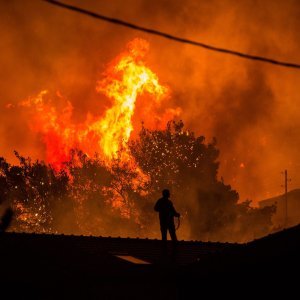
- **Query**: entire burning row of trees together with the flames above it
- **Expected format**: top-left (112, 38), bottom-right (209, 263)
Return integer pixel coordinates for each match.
top-left (0, 39), bottom-right (274, 241)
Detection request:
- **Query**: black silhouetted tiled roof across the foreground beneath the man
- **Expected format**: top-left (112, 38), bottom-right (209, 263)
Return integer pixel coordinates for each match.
top-left (0, 225), bottom-right (300, 299)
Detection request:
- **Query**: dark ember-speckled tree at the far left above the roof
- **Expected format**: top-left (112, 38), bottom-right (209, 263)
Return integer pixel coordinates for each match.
top-left (0, 152), bottom-right (68, 232)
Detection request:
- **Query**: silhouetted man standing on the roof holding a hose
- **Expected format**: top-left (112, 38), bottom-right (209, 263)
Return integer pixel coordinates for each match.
top-left (154, 189), bottom-right (180, 242)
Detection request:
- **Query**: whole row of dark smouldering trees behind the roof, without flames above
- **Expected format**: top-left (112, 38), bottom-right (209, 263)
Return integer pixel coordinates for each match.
top-left (0, 121), bottom-right (275, 242)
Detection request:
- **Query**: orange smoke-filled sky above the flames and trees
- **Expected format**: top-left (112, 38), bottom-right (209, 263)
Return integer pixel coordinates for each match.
top-left (0, 0), bottom-right (300, 201)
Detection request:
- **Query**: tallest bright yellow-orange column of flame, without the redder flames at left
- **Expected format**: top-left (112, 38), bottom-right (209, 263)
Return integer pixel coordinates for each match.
top-left (93, 39), bottom-right (167, 159)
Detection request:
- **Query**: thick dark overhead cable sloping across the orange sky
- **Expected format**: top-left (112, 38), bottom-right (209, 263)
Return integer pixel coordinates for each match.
top-left (42, 0), bottom-right (300, 69)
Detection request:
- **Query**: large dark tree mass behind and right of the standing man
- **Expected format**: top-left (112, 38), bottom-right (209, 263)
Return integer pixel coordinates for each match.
top-left (130, 121), bottom-right (273, 241)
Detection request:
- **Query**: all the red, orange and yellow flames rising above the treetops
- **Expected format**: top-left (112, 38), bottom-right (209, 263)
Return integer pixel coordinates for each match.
top-left (22, 39), bottom-right (180, 169)
